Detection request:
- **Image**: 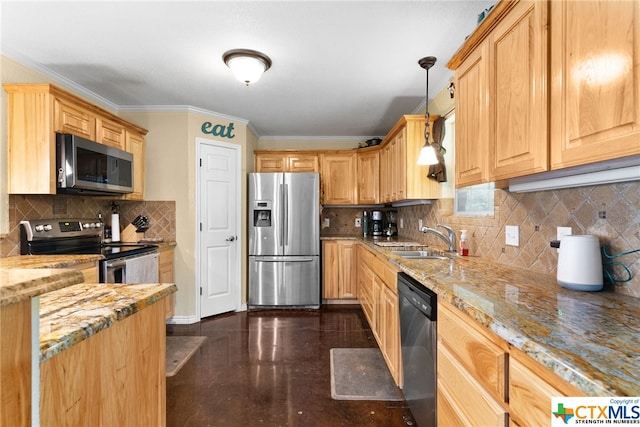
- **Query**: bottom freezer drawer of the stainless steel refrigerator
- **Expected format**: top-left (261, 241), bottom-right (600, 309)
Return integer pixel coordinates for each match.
top-left (248, 256), bottom-right (320, 308)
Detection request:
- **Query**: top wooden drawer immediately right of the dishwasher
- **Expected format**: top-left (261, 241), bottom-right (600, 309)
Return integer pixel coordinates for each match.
top-left (438, 303), bottom-right (508, 402)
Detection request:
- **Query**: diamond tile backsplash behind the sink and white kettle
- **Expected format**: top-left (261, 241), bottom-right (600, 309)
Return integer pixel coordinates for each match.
top-left (322, 182), bottom-right (640, 297)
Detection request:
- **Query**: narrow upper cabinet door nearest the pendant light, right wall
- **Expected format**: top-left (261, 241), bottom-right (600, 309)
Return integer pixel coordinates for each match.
top-left (455, 42), bottom-right (489, 187)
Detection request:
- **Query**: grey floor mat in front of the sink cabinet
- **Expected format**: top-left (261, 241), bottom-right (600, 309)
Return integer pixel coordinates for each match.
top-left (330, 348), bottom-right (404, 401)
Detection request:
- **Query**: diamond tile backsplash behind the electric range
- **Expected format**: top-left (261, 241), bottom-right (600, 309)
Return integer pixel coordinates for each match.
top-left (0, 195), bottom-right (176, 257)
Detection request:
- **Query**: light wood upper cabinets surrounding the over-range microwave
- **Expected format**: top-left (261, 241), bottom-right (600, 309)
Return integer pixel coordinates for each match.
top-left (3, 84), bottom-right (147, 198)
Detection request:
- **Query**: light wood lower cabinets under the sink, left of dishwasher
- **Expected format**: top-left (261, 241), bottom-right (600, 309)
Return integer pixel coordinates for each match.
top-left (358, 244), bottom-right (402, 387)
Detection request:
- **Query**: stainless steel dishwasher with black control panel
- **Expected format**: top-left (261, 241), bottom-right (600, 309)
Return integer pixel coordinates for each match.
top-left (398, 273), bottom-right (437, 427)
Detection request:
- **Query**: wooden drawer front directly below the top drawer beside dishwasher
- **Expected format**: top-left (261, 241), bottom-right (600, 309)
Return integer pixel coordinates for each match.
top-left (437, 346), bottom-right (508, 427)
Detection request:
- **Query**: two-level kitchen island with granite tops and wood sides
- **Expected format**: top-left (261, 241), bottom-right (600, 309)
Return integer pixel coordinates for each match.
top-left (0, 256), bottom-right (177, 426)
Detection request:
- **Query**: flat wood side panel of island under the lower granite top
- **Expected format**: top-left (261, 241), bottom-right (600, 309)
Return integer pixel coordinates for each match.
top-left (40, 302), bottom-right (166, 426)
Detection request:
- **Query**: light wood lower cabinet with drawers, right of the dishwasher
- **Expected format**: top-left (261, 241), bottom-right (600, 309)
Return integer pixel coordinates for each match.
top-left (437, 298), bottom-right (584, 426)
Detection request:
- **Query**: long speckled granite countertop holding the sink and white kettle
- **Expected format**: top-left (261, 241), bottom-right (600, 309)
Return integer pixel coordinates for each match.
top-left (332, 236), bottom-right (640, 396)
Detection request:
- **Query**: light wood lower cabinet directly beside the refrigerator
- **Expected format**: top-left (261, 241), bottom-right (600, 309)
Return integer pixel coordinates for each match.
top-left (322, 240), bottom-right (358, 299)
